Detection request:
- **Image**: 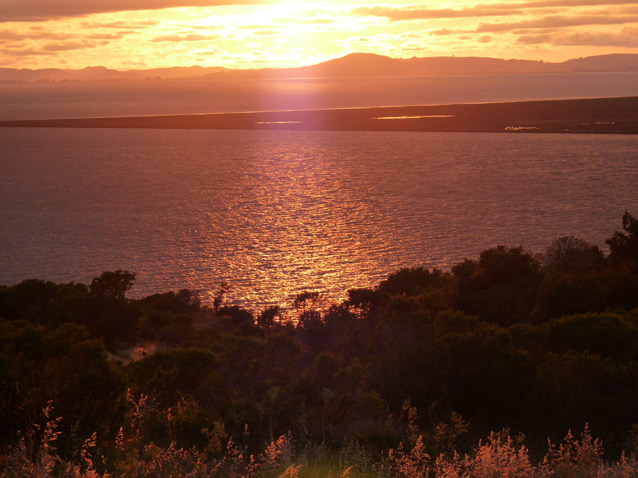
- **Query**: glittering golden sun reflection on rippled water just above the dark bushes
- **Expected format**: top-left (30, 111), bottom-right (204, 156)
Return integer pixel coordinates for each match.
top-left (196, 140), bottom-right (396, 306)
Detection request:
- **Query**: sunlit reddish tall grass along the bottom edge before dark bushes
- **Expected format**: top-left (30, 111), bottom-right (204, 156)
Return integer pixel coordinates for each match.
top-left (0, 408), bottom-right (638, 478)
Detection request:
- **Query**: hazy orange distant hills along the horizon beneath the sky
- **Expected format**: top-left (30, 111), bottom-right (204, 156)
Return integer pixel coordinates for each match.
top-left (0, 53), bottom-right (638, 83)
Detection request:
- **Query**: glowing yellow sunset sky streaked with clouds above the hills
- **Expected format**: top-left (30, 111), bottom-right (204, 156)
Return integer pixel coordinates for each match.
top-left (0, 0), bottom-right (638, 69)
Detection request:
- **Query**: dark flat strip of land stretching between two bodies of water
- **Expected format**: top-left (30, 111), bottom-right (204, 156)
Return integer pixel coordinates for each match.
top-left (0, 96), bottom-right (638, 134)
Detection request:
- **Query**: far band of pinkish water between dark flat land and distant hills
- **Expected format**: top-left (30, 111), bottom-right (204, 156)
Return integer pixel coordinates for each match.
top-left (0, 73), bottom-right (638, 120)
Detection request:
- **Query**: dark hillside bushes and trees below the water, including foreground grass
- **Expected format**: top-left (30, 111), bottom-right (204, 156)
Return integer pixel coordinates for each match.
top-left (0, 212), bottom-right (638, 478)
